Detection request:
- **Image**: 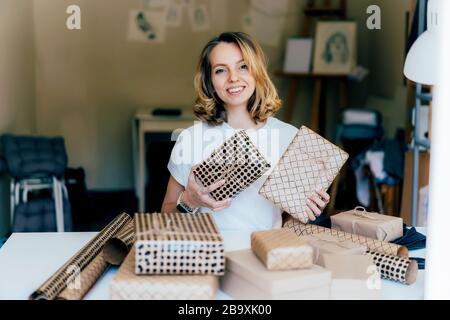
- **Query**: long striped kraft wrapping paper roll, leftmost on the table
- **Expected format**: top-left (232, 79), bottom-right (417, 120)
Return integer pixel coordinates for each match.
top-left (29, 213), bottom-right (132, 300)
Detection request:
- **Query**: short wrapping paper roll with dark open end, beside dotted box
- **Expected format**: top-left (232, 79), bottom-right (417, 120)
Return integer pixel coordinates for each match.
top-left (102, 220), bottom-right (135, 266)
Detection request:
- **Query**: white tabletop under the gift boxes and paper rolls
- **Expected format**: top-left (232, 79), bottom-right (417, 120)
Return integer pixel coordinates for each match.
top-left (0, 228), bottom-right (425, 300)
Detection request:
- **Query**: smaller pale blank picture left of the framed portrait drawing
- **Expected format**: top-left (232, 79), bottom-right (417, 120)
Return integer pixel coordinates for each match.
top-left (283, 38), bottom-right (313, 73)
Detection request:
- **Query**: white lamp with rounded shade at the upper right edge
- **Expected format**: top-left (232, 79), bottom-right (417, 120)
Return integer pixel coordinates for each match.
top-left (403, 0), bottom-right (439, 85)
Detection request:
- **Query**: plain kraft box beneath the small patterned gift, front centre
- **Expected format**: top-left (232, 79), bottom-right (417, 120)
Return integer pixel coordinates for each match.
top-left (220, 249), bottom-right (331, 300)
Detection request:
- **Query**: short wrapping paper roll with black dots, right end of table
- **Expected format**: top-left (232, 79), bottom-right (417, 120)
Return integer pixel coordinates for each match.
top-left (366, 250), bottom-right (419, 284)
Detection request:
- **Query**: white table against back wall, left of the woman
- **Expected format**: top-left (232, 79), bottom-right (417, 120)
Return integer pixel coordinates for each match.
top-left (131, 109), bottom-right (194, 212)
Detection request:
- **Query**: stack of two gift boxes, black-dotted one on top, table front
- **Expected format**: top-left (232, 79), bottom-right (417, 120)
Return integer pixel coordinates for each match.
top-left (111, 213), bottom-right (225, 300)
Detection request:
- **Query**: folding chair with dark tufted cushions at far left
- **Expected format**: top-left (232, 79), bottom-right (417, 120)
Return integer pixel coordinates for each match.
top-left (0, 134), bottom-right (72, 232)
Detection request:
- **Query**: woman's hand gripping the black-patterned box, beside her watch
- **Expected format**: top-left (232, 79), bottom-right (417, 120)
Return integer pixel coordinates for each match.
top-left (181, 170), bottom-right (231, 211)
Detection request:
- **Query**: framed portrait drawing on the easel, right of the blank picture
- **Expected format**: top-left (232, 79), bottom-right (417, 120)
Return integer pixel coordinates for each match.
top-left (313, 21), bottom-right (356, 74)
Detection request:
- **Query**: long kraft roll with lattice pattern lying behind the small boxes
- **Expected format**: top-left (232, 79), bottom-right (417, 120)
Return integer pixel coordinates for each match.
top-left (283, 216), bottom-right (409, 258)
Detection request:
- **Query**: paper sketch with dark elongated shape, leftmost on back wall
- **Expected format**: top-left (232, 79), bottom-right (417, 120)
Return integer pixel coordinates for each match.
top-left (128, 9), bottom-right (166, 43)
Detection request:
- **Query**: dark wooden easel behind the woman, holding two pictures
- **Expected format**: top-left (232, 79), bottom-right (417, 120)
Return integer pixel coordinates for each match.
top-left (275, 0), bottom-right (348, 134)
